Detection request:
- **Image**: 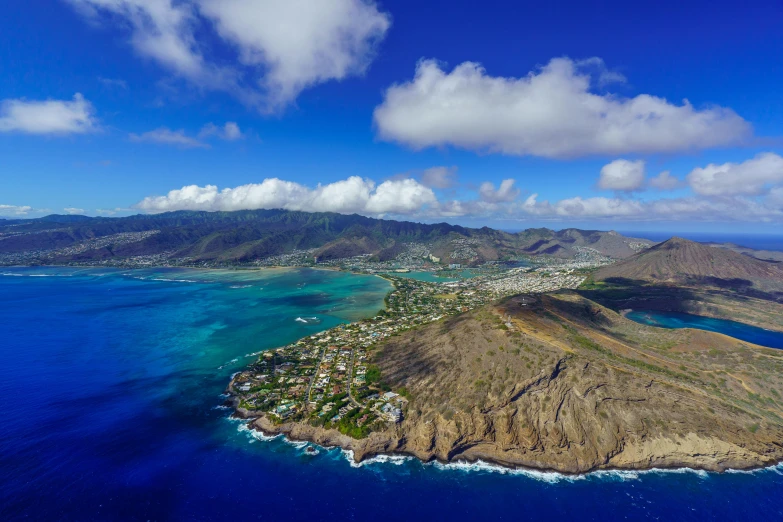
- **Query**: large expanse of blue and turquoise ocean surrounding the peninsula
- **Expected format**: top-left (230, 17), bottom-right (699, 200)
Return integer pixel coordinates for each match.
top-left (0, 269), bottom-right (783, 521)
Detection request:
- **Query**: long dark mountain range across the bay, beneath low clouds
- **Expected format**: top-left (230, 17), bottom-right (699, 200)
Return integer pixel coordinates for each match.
top-left (0, 210), bottom-right (653, 265)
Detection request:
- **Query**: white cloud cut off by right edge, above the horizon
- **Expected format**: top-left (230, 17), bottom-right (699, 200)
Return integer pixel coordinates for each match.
top-left (686, 152), bottom-right (783, 196)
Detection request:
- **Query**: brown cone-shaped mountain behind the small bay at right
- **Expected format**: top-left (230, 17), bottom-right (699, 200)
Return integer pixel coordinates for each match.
top-left (594, 237), bottom-right (783, 290)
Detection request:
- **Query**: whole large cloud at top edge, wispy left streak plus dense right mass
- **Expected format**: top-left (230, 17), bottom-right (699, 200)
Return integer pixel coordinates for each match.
top-left (69, 0), bottom-right (391, 110)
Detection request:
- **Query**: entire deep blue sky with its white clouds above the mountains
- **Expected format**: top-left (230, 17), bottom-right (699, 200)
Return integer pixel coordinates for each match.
top-left (0, 0), bottom-right (783, 231)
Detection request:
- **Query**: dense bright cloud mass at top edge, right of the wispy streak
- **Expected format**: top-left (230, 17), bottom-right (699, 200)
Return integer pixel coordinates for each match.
top-left (199, 0), bottom-right (391, 107)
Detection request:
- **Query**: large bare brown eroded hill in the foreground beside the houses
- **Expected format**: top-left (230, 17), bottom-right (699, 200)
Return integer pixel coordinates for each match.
top-left (366, 293), bottom-right (783, 472)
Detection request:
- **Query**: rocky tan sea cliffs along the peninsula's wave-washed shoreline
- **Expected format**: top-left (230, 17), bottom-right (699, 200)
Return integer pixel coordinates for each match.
top-left (222, 268), bottom-right (783, 476)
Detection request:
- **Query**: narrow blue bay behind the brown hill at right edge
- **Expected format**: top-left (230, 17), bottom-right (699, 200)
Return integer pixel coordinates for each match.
top-left (626, 310), bottom-right (783, 348)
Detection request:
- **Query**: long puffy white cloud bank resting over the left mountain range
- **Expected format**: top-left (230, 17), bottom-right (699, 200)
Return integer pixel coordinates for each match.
top-left (136, 176), bottom-right (437, 215)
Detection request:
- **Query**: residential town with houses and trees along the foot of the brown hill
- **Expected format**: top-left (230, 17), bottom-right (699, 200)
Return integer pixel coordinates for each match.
top-left (229, 266), bottom-right (585, 438)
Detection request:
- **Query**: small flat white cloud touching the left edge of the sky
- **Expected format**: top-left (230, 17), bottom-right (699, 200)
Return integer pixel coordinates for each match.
top-left (0, 93), bottom-right (98, 135)
